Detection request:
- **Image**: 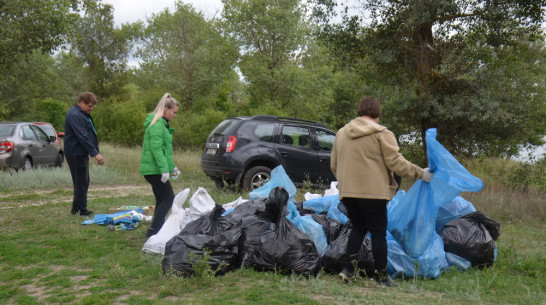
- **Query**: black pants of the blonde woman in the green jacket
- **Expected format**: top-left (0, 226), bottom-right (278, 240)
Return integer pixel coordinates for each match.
top-left (144, 175), bottom-right (174, 236)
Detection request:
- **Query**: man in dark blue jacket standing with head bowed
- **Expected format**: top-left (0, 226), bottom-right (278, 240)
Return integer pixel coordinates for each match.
top-left (64, 92), bottom-right (104, 216)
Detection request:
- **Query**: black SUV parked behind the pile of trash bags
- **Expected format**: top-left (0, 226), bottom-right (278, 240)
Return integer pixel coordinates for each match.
top-left (201, 115), bottom-right (336, 190)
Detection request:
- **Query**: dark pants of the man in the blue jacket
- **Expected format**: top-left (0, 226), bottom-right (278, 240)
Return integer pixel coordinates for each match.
top-left (66, 156), bottom-right (89, 214)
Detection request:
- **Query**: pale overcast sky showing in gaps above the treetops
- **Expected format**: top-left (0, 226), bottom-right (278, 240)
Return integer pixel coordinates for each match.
top-left (102, 0), bottom-right (222, 26)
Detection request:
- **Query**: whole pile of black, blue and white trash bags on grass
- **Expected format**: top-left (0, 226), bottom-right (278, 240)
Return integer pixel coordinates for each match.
top-left (142, 129), bottom-right (500, 278)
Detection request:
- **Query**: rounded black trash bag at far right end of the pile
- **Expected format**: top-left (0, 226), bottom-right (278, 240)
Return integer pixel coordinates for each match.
top-left (440, 212), bottom-right (500, 268)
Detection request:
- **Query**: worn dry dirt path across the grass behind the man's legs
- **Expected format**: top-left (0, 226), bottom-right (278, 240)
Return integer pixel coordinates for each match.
top-left (0, 185), bottom-right (152, 210)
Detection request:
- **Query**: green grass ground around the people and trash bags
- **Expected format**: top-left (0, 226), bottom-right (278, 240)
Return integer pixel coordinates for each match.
top-left (0, 145), bottom-right (546, 304)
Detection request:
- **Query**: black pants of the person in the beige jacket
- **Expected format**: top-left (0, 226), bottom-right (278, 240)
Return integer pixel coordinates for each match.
top-left (342, 198), bottom-right (387, 274)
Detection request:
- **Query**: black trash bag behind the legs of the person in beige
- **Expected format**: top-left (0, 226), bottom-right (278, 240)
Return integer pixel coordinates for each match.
top-left (322, 221), bottom-right (375, 276)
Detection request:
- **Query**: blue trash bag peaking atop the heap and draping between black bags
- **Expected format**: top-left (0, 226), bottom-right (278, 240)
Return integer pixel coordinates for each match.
top-left (248, 165), bottom-right (328, 255)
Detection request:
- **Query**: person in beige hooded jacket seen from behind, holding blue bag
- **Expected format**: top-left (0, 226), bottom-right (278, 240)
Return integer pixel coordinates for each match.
top-left (330, 97), bottom-right (433, 286)
